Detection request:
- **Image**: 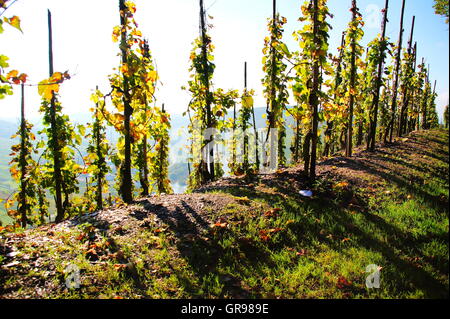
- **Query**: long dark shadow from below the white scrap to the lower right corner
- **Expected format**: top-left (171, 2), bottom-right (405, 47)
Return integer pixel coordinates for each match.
top-left (214, 179), bottom-right (448, 298)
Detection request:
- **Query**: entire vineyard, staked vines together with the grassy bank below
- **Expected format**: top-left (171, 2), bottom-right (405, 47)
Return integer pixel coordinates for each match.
top-left (0, 0), bottom-right (449, 299)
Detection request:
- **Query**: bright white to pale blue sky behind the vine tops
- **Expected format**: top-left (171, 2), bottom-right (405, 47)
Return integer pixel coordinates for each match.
top-left (0, 0), bottom-right (449, 120)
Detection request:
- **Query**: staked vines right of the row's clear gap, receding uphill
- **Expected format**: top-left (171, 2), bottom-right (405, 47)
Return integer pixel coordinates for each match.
top-left (183, 0), bottom-right (439, 189)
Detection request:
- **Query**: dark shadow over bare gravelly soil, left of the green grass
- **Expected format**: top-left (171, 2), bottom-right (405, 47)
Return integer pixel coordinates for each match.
top-left (134, 200), bottom-right (267, 298)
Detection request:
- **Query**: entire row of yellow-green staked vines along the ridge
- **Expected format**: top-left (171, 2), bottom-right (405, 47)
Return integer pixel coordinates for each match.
top-left (0, 0), bottom-right (438, 227)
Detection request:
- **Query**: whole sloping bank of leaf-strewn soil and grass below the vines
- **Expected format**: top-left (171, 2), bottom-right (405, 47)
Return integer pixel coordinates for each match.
top-left (0, 130), bottom-right (449, 298)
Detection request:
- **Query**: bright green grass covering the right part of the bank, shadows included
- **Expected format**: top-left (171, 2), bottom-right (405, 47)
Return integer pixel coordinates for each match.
top-left (185, 131), bottom-right (449, 298)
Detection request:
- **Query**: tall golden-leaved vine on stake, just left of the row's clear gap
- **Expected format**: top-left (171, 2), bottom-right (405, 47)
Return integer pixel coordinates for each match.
top-left (96, 0), bottom-right (165, 203)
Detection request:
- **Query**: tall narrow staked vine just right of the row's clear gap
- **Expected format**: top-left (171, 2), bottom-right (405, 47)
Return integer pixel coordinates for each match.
top-left (182, 0), bottom-right (238, 190)
